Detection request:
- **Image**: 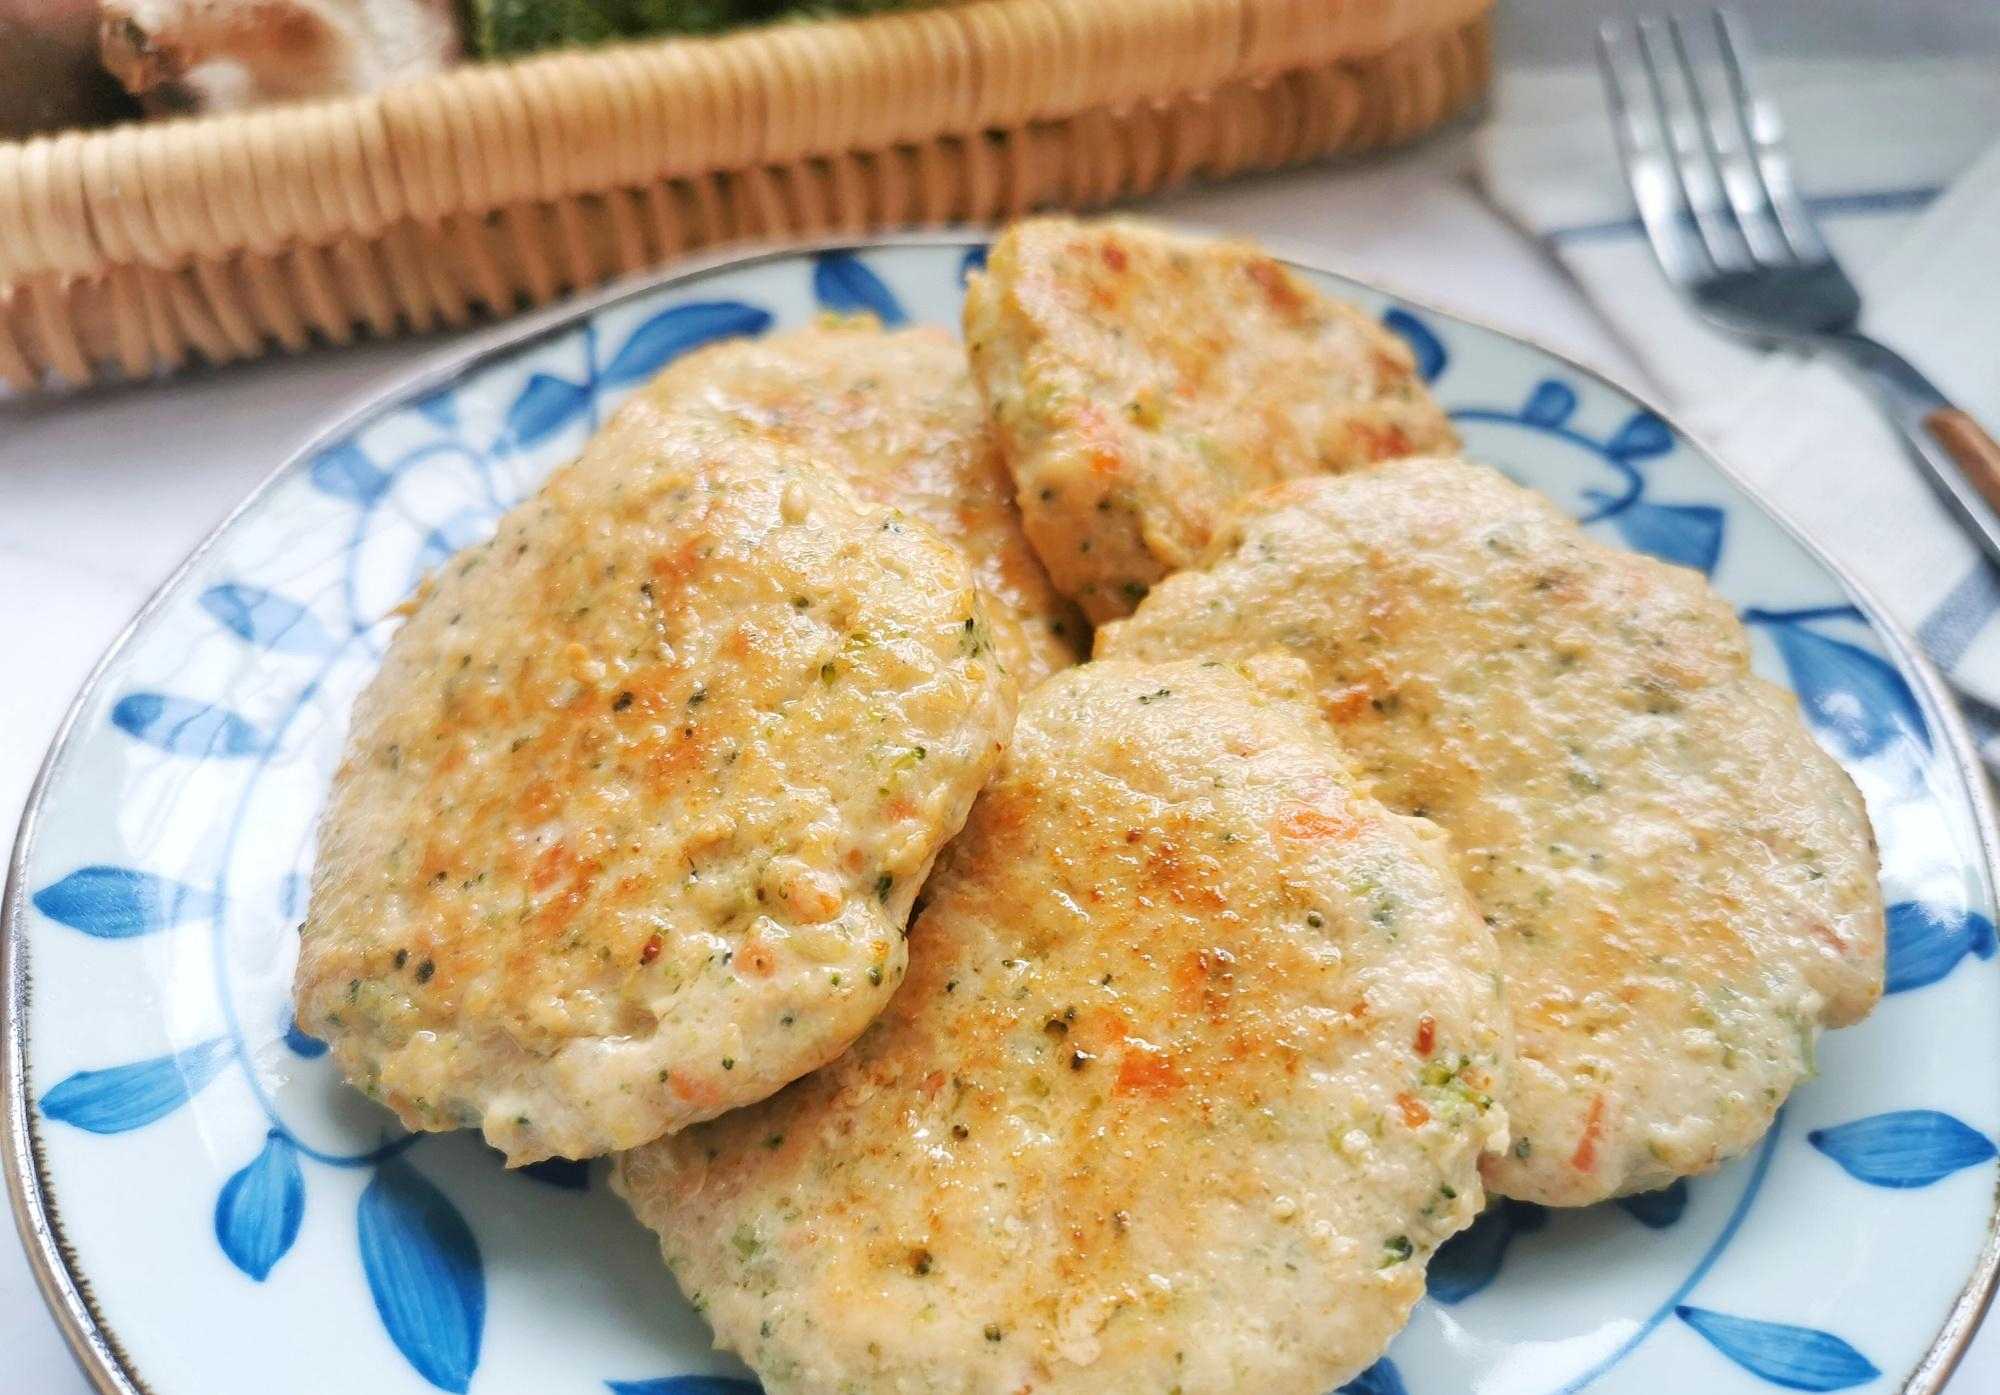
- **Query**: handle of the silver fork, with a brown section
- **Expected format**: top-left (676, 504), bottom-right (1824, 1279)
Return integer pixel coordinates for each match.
top-left (1822, 332), bottom-right (2000, 566)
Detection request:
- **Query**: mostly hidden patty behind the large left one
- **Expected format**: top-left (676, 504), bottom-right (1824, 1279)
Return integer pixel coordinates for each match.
top-left (646, 316), bottom-right (1086, 692)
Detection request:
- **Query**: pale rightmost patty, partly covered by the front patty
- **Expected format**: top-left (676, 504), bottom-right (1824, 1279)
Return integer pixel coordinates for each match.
top-left (1098, 460), bottom-right (1884, 1205)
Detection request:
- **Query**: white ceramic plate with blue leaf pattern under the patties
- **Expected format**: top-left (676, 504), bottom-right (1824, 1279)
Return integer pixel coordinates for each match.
top-left (11, 240), bottom-right (2000, 1395)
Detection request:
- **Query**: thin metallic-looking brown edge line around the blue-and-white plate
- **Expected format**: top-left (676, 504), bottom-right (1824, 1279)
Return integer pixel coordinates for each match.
top-left (0, 227), bottom-right (2000, 1395)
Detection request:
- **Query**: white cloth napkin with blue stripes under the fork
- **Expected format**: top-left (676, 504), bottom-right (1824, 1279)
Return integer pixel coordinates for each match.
top-left (1478, 60), bottom-right (2000, 751)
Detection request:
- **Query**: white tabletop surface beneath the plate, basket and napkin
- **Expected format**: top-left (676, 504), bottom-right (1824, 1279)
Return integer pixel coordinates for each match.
top-left (0, 0), bottom-right (2000, 1395)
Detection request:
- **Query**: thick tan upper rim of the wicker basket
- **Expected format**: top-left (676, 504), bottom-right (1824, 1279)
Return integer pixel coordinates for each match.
top-left (0, 0), bottom-right (1492, 271)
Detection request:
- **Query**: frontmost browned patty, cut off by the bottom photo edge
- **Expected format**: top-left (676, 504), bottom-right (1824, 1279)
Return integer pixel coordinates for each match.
top-left (616, 658), bottom-right (1506, 1395)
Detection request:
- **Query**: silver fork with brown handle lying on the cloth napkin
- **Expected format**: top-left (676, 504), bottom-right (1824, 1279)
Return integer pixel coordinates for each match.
top-left (1598, 10), bottom-right (2000, 564)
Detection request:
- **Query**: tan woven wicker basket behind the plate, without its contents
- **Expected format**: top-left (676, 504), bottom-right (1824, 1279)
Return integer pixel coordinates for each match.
top-left (0, 0), bottom-right (1490, 390)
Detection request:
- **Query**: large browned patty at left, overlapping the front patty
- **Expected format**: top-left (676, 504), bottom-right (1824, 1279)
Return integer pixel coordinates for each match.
top-left (298, 402), bottom-right (1014, 1163)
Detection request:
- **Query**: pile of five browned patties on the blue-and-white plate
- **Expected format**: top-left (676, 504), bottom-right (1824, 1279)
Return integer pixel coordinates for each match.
top-left (300, 220), bottom-right (1882, 1395)
